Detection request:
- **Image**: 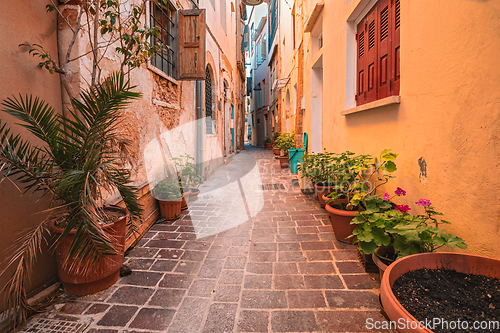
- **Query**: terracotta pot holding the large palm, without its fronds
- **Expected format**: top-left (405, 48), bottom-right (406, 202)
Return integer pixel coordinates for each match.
top-left (49, 207), bottom-right (130, 296)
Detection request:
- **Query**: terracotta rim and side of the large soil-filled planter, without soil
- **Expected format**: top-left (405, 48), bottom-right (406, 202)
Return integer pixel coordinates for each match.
top-left (380, 252), bottom-right (500, 333)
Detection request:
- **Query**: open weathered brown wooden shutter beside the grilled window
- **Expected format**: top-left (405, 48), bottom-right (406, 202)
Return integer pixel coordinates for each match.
top-left (178, 9), bottom-right (205, 80)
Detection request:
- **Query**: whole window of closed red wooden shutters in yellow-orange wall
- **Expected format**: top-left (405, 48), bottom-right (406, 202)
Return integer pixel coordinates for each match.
top-left (356, 0), bottom-right (400, 105)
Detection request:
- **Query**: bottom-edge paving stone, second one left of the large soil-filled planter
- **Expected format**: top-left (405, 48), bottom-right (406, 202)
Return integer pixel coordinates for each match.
top-left (271, 311), bottom-right (320, 332)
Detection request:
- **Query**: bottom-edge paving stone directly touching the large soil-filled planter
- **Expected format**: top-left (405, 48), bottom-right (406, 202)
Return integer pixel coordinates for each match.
top-left (316, 311), bottom-right (388, 332)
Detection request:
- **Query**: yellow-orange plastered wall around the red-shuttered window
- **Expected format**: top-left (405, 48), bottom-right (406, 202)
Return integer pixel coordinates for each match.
top-left (304, 0), bottom-right (500, 258)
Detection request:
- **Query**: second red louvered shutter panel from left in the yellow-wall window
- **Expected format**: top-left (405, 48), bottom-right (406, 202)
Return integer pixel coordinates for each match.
top-left (365, 5), bottom-right (378, 103)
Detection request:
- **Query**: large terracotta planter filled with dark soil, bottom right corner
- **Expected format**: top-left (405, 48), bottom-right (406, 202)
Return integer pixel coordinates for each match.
top-left (380, 252), bottom-right (500, 333)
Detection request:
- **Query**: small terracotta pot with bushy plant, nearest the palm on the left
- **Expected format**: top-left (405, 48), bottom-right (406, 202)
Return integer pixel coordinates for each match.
top-left (153, 178), bottom-right (183, 220)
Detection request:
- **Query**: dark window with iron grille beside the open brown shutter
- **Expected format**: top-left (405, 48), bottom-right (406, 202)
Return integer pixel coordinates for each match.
top-left (150, 1), bottom-right (177, 77)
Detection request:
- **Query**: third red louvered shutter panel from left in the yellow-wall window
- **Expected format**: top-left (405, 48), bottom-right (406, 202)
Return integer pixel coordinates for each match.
top-left (377, 0), bottom-right (392, 99)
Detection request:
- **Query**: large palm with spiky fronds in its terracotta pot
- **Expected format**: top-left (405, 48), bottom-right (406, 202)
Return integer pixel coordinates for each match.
top-left (0, 73), bottom-right (141, 321)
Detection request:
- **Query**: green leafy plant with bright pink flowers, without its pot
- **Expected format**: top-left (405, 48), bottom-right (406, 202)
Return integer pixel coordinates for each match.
top-left (351, 187), bottom-right (467, 259)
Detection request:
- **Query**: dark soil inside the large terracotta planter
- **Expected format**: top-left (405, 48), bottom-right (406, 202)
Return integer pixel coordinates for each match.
top-left (392, 269), bottom-right (500, 332)
